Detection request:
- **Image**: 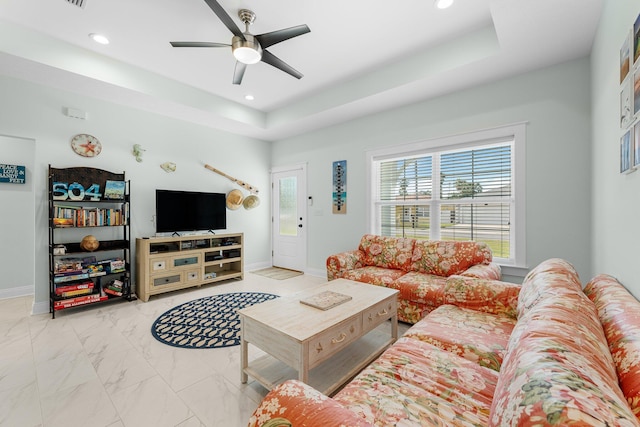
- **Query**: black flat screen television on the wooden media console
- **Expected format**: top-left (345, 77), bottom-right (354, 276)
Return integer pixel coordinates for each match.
top-left (156, 190), bottom-right (227, 233)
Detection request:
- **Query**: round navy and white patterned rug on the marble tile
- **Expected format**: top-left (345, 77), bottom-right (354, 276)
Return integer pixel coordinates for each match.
top-left (151, 292), bottom-right (278, 348)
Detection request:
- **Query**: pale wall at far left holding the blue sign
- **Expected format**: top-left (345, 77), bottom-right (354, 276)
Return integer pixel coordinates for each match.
top-left (0, 135), bottom-right (36, 298)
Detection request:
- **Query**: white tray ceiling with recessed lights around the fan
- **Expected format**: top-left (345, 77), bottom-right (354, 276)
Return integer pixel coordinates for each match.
top-left (0, 0), bottom-right (604, 140)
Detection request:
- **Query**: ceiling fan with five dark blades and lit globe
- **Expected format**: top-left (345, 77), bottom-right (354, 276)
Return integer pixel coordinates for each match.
top-left (170, 0), bottom-right (311, 85)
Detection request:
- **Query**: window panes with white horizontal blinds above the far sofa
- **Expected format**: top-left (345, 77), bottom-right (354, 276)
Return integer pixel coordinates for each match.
top-left (371, 137), bottom-right (515, 260)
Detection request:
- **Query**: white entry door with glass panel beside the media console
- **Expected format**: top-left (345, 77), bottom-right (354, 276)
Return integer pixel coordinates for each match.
top-left (271, 165), bottom-right (307, 271)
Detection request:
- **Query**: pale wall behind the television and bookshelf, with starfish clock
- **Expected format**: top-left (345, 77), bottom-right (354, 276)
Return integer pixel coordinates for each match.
top-left (0, 77), bottom-right (271, 311)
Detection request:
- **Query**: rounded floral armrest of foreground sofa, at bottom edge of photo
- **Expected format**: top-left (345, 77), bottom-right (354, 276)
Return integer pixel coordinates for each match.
top-left (248, 380), bottom-right (372, 427)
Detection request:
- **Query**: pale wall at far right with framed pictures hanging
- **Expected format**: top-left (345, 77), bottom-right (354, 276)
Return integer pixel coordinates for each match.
top-left (591, 0), bottom-right (640, 298)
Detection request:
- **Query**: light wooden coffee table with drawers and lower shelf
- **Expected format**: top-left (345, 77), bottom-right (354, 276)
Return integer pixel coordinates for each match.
top-left (238, 279), bottom-right (398, 395)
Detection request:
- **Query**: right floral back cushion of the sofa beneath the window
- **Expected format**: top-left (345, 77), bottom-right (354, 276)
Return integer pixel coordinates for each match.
top-left (410, 240), bottom-right (492, 277)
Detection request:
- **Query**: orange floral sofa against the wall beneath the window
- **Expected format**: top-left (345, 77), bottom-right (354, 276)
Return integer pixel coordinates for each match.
top-left (326, 234), bottom-right (520, 323)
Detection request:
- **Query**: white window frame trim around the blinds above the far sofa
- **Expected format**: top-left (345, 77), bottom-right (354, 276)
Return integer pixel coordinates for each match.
top-left (366, 123), bottom-right (526, 267)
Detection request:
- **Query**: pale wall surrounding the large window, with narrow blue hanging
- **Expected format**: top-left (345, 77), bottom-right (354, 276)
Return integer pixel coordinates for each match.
top-left (272, 58), bottom-right (592, 281)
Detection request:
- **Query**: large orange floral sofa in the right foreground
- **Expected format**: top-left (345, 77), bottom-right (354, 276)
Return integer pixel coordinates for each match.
top-left (249, 259), bottom-right (640, 427)
